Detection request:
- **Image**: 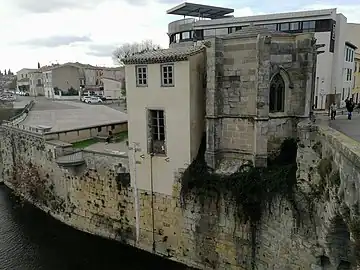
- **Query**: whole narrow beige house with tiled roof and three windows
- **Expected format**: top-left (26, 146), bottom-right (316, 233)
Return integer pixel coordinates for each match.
top-left (125, 46), bottom-right (205, 194)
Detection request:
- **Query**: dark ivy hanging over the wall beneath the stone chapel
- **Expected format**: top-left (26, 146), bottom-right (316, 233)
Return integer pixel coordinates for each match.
top-left (181, 135), bottom-right (299, 269)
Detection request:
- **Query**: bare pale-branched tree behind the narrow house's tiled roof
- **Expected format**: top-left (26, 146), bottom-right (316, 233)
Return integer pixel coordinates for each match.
top-left (113, 40), bottom-right (161, 66)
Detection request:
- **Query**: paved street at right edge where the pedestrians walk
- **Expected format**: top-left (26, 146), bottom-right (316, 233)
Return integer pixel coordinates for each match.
top-left (330, 112), bottom-right (360, 142)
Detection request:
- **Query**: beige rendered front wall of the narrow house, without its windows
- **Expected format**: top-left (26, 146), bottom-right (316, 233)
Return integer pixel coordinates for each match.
top-left (125, 61), bottom-right (191, 195)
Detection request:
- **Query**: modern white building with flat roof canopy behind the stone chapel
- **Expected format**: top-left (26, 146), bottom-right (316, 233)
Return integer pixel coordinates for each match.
top-left (167, 3), bottom-right (347, 109)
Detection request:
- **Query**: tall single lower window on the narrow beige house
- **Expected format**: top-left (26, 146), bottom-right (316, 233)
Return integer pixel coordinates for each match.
top-left (149, 110), bottom-right (166, 154)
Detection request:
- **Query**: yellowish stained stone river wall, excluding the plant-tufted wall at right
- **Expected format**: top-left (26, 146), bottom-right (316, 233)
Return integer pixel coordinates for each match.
top-left (0, 123), bottom-right (330, 270)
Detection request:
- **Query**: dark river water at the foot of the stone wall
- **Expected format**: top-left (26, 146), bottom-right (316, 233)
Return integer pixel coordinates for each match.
top-left (0, 184), bottom-right (186, 270)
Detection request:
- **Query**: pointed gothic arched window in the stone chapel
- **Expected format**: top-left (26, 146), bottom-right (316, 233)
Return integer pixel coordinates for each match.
top-left (269, 74), bottom-right (285, 112)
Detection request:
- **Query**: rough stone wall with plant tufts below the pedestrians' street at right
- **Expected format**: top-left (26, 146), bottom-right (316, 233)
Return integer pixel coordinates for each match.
top-left (297, 122), bottom-right (360, 269)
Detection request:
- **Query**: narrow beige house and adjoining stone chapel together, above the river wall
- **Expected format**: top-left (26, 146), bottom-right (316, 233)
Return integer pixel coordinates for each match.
top-left (124, 26), bottom-right (318, 194)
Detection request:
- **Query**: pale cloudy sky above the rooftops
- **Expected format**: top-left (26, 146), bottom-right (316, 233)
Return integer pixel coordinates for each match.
top-left (0, 0), bottom-right (360, 72)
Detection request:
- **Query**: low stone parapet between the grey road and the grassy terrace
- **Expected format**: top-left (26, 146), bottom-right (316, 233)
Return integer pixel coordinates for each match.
top-left (45, 122), bottom-right (128, 143)
